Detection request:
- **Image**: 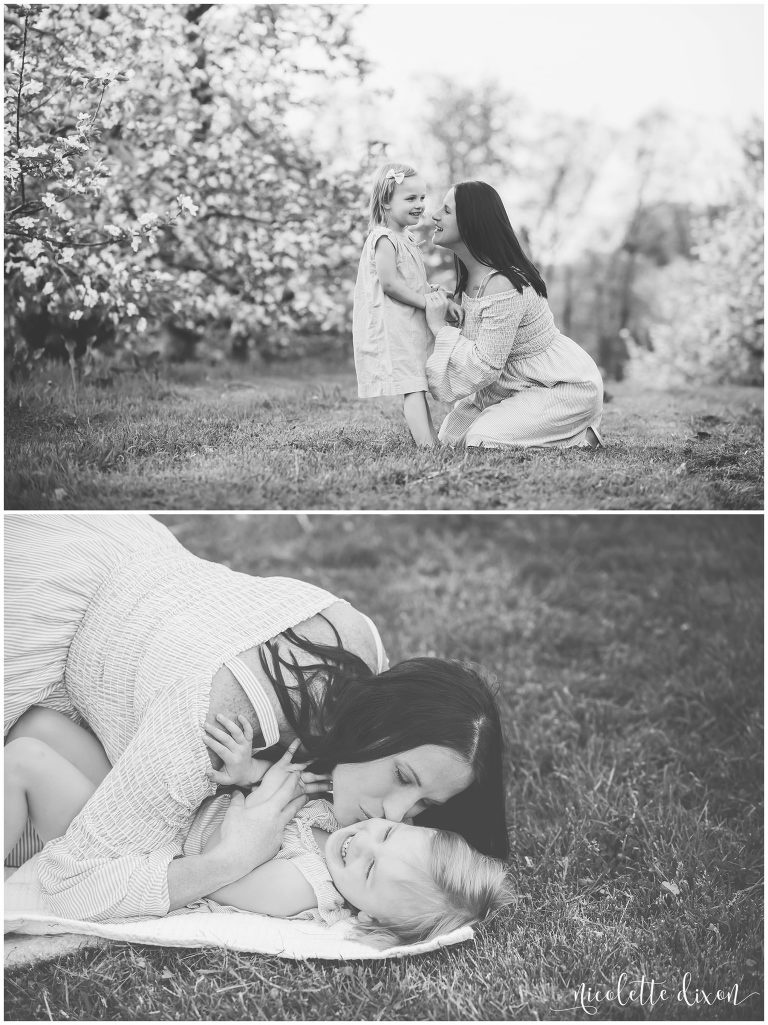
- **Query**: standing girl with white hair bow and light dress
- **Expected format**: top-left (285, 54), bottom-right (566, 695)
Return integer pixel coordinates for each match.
top-left (353, 164), bottom-right (461, 446)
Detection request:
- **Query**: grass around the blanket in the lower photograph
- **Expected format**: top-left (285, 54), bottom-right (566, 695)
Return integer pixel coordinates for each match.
top-left (5, 514), bottom-right (763, 1021)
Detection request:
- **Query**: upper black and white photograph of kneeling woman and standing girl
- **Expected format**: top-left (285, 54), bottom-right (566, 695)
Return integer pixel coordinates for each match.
top-left (5, 3), bottom-right (764, 511)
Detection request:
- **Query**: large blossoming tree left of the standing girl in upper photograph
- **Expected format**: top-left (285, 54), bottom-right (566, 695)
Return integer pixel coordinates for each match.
top-left (5, 4), bottom-right (366, 361)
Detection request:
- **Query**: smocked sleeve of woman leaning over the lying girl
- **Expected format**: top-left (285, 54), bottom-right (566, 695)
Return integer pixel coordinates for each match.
top-left (38, 688), bottom-right (212, 921)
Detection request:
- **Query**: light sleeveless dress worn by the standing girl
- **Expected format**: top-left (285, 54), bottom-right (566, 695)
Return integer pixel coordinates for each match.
top-left (352, 226), bottom-right (432, 399)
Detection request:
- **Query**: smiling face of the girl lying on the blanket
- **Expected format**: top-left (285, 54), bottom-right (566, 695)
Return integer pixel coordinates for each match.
top-left (325, 819), bottom-right (435, 921)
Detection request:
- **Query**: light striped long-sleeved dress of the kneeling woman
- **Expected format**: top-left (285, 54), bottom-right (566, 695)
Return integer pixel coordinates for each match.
top-left (427, 273), bottom-right (603, 448)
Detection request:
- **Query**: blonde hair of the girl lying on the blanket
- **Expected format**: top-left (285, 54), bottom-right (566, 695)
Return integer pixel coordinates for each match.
top-left (357, 829), bottom-right (514, 947)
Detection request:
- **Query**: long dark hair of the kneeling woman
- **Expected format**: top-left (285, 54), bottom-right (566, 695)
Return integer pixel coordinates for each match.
top-left (453, 181), bottom-right (547, 301)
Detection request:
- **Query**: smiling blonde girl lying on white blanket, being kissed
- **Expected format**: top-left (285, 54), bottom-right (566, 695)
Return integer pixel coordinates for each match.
top-left (4, 709), bottom-right (511, 945)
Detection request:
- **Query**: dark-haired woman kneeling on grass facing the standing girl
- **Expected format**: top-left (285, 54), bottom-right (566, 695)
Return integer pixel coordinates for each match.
top-left (427, 181), bottom-right (603, 448)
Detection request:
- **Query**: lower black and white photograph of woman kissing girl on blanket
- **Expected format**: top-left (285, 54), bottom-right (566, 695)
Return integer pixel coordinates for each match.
top-left (4, 513), bottom-right (763, 1021)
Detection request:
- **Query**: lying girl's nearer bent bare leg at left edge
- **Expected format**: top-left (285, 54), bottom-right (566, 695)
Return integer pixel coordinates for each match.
top-left (3, 737), bottom-right (96, 858)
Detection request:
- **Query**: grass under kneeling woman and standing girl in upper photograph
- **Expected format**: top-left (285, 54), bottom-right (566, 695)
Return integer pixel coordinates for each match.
top-left (5, 362), bottom-right (763, 510)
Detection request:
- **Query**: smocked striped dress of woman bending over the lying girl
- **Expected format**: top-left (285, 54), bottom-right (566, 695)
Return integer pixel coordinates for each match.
top-left (5, 514), bottom-right (386, 920)
